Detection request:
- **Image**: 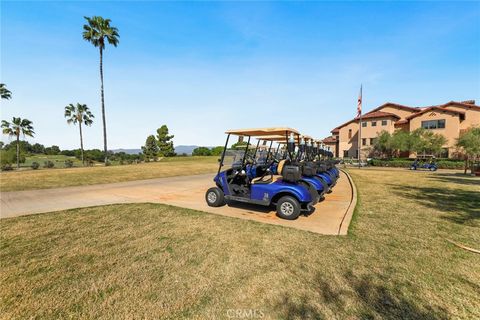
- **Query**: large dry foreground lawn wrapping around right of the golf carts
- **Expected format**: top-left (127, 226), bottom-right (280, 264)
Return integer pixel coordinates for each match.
top-left (0, 169), bottom-right (480, 319)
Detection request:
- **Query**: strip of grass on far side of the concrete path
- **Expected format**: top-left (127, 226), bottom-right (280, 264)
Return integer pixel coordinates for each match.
top-left (0, 157), bottom-right (218, 192)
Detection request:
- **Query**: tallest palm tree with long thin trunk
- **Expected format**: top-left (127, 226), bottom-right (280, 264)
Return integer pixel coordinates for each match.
top-left (83, 16), bottom-right (120, 165)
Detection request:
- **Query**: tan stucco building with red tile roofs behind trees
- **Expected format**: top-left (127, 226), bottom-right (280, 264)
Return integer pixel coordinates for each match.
top-left (324, 100), bottom-right (480, 158)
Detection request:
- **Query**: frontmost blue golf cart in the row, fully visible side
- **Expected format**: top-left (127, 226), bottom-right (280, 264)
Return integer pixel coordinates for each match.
top-left (205, 128), bottom-right (319, 220)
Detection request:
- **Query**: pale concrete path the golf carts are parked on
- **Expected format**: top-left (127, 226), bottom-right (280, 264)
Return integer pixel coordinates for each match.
top-left (0, 172), bottom-right (356, 235)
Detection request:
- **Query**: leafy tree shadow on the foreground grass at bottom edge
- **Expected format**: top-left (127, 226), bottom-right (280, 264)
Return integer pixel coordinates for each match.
top-left (277, 272), bottom-right (448, 320)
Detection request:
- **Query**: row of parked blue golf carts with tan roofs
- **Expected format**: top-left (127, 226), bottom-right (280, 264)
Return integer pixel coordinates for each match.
top-left (205, 128), bottom-right (339, 220)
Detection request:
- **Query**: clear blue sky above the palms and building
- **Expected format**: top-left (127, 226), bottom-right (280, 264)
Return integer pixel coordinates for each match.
top-left (0, 1), bottom-right (480, 149)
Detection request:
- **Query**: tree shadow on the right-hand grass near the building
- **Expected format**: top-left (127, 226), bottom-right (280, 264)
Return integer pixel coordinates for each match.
top-left (389, 184), bottom-right (480, 225)
